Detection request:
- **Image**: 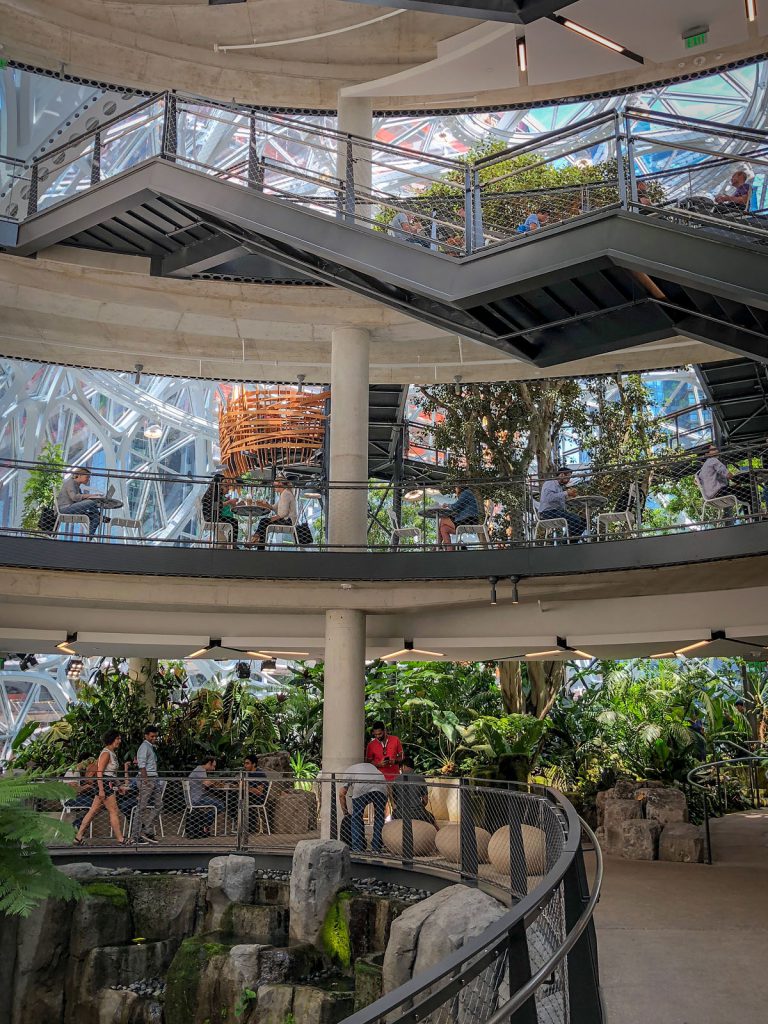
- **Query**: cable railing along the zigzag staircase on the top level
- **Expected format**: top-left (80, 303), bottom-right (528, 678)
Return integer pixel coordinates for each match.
top-left (0, 93), bottom-right (768, 257)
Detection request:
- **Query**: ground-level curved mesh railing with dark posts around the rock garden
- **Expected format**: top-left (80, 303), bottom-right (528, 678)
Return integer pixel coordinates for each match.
top-left (24, 770), bottom-right (602, 1024)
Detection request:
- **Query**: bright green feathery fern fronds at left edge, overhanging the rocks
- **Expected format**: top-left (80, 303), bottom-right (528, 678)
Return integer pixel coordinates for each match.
top-left (0, 774), bottom-right (80, 918)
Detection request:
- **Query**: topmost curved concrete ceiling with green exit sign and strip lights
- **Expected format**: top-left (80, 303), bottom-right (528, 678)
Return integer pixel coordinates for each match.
top-left (0, 0), bottom-right (768, 110)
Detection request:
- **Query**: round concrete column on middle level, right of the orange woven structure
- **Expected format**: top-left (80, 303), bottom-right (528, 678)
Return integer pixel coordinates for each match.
top-left (328, 328), bottom-right (370, 548)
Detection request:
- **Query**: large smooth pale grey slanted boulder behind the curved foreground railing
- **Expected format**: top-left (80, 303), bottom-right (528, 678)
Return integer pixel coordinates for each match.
top-left (382, 885), bottom-right (507, 1024)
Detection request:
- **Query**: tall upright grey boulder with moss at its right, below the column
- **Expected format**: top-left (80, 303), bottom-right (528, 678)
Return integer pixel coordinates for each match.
top-left (290, 840), bottom-right (352, 945)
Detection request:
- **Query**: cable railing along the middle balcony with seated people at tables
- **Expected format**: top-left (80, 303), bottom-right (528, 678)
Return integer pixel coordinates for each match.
top-left (0, 443), bottom-right (768, 558)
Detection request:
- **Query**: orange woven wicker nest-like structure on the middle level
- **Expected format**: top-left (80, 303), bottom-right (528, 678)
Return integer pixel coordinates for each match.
top-left (219, 387), bottom-right (331, 476)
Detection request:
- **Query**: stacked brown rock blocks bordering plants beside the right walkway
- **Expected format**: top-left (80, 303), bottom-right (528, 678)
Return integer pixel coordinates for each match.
top-left (597, 779), bottom-right (703, 864)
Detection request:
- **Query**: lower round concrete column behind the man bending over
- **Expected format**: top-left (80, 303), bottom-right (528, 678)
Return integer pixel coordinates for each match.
top-left (321, 610), bottom-right (366, 839)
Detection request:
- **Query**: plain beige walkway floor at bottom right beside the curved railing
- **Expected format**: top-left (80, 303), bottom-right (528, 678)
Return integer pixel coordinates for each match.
top-left (596, 811), bottom-right (768, 1024)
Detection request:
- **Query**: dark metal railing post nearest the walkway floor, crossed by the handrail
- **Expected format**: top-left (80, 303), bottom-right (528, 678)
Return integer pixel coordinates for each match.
top-left (563, 845), bottom-right (604, 1024)
